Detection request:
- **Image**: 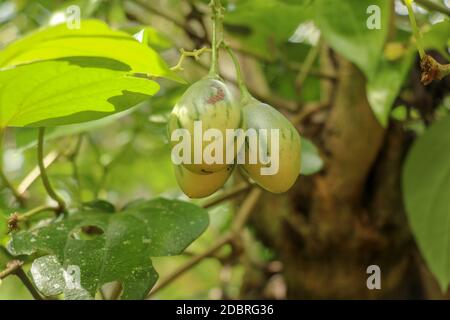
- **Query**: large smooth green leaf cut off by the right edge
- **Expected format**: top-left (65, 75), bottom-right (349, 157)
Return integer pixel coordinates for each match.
top-left (402, 116), bottom-right (450, 292)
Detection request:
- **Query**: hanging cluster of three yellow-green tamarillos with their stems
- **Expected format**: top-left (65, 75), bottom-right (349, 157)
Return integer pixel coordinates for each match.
top-left (168, 3), bottom-right (301, 198)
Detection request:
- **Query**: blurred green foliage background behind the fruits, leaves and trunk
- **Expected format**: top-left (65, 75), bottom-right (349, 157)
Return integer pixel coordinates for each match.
top-left (0, 0), bottom-right (450, 299)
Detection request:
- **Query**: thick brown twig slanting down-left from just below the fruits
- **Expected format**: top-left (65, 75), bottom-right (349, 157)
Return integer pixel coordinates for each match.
top-left (147, 187), bottom-right (262, 299)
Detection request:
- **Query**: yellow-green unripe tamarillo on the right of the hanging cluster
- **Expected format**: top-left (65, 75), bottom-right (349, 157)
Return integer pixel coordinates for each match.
top-left (241, 99), bottom-right (301, 193)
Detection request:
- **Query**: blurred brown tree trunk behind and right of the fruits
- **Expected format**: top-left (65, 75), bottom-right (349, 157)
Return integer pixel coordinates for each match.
top-left (243, 58), bottom-right (436, 299)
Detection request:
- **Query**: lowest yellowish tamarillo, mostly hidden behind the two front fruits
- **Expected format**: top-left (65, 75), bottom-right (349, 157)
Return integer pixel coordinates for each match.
top-left (173, 165), bottom-right (234, 199)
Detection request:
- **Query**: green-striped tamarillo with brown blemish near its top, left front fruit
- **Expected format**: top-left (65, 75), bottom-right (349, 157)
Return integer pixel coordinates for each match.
top-left (168, 77), bottom-right (241, 174)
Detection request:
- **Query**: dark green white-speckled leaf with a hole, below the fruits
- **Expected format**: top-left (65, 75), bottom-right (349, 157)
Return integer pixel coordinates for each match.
top-left (8, 199), bottom-right (209, 299)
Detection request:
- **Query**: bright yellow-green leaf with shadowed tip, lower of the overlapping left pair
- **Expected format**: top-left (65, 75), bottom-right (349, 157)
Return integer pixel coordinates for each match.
top-left (0, 58), bottom-right (159, 128)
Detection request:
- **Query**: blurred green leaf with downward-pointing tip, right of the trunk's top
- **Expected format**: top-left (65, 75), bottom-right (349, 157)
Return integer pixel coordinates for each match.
top-left (366, 49), bottom-right (415, 127)
